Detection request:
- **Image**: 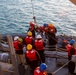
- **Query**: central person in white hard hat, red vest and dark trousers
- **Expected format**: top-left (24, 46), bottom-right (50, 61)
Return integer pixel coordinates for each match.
top-left (34, 34), bottom-right (45, 63)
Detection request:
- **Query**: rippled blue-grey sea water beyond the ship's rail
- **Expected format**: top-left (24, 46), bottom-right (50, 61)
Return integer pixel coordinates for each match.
top-left (0, 0), bottom-right (76, 35)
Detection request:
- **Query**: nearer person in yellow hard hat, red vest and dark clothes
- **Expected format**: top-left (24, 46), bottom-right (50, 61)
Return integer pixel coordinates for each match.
top-left (25, 44), bottom-right (40, 70)
